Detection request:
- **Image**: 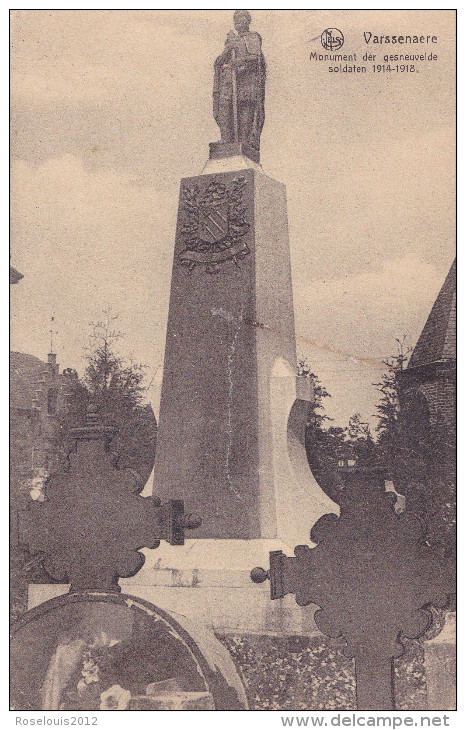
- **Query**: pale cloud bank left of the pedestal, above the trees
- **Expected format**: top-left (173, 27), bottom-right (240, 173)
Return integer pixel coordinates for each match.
top-left (12, 155), bottom-right (176, 367)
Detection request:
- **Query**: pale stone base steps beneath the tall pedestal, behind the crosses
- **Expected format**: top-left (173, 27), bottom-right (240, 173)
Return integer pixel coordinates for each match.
top-left (29, 539), bottom-right (321, 636)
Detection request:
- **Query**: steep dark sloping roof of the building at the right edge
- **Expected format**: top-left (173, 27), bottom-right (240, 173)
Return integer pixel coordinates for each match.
top-left (408, 259), bottom-right (456, 368)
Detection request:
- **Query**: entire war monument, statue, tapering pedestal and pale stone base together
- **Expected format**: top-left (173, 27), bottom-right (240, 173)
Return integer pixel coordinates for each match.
top-left (33, 11), bottom-right (338, 633)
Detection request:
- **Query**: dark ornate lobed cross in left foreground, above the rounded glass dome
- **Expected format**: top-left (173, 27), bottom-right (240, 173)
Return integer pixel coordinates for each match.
top-left (20, 405), bottom-right (200, 592)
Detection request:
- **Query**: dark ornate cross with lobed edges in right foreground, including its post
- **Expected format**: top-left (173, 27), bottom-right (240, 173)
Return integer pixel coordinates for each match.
top-left (251, 468), bottom-right (455, 710)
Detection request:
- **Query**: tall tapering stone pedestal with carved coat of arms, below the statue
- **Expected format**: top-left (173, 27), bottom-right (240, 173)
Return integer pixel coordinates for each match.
top-left (153, 163), bottom-right (336, 544)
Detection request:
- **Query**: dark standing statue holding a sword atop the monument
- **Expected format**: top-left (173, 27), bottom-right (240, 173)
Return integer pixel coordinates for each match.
top-left (213, 10), bottom-right (266, 150)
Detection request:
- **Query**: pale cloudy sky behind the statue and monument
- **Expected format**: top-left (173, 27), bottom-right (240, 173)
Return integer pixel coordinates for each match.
top-left (11, 10), bottom-right (455, 425)
